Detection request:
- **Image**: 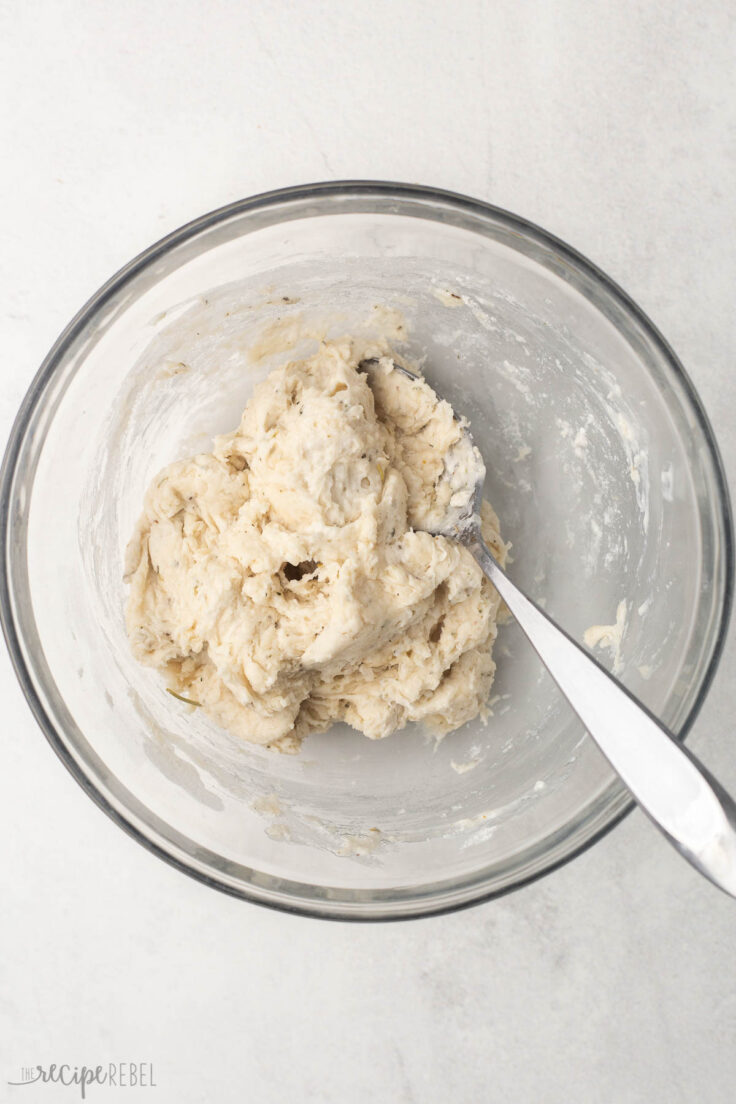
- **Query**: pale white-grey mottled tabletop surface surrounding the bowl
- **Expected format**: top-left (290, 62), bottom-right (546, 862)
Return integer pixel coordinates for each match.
top-left (0, 0), bottom-right (736, 1104)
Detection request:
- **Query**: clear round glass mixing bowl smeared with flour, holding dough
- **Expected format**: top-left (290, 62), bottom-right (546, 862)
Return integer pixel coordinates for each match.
top-left (0, 182), bottom-right (733, 920)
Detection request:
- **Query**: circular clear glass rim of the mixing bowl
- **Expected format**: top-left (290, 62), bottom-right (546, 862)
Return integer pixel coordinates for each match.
top-left (0, 179), bottom-right (734, 922)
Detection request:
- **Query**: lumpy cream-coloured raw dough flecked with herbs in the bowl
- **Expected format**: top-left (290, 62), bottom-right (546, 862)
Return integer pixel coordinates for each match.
top-left (126, 340), bottom-right (506, 751)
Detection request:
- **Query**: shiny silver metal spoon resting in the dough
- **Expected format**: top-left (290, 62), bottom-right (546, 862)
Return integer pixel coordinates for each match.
top-left (360, 359), bottom-right (736, 896)
